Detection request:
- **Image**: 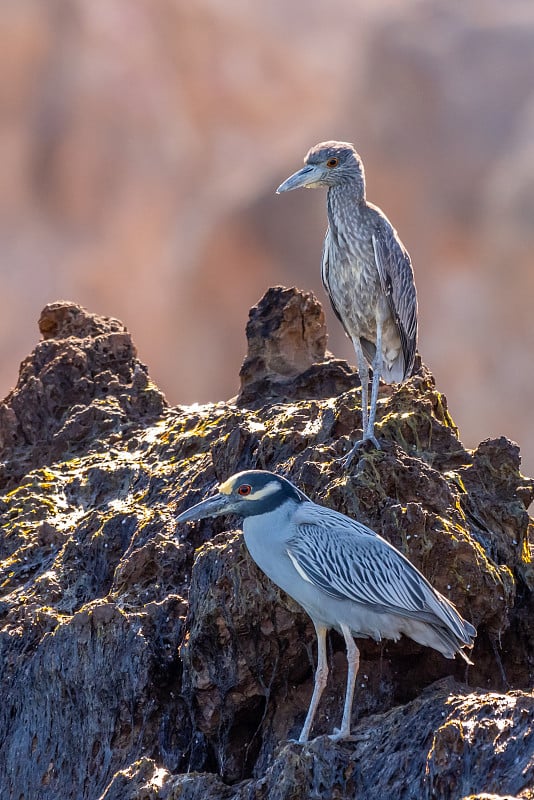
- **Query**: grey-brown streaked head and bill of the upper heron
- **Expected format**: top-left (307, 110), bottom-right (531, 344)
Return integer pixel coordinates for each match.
top-left (276, 142), bottom-right (365, 197)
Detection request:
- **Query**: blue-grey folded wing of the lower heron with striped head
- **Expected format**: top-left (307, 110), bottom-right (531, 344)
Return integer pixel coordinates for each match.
top-left (287, 503), bottom-right (471, 641)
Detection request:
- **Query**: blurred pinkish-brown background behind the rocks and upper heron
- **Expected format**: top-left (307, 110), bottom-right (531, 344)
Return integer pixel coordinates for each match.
top-left (0, 0), bottom-right (534, 474)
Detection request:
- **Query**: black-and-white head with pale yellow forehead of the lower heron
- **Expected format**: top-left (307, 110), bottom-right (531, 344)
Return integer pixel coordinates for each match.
top-left (176, 470), bottom-right (308, 522)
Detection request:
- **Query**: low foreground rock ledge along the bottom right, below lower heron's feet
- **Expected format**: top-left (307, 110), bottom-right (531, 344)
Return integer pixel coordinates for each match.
top-left (102, 681), bottom-right (534, 800)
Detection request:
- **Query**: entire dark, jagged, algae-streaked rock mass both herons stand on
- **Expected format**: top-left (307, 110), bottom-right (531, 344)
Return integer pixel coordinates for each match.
top-left (0, 294), bottom-right (534, 800)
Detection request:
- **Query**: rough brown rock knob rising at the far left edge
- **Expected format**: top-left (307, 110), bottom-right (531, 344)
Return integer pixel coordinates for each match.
top-left (0, 303), bottom-right (166, 490)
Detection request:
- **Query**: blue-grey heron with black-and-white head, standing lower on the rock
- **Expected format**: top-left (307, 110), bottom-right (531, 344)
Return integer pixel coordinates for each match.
top-left (177, 470), bottom-right (476, 742)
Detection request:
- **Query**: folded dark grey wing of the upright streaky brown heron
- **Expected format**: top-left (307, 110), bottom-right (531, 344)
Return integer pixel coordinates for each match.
top-left (373, 218), bottom-right (417, 378)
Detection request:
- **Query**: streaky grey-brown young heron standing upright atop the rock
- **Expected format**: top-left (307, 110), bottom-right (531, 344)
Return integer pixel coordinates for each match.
top-left (276, 142), bottom-right (417, 466)
